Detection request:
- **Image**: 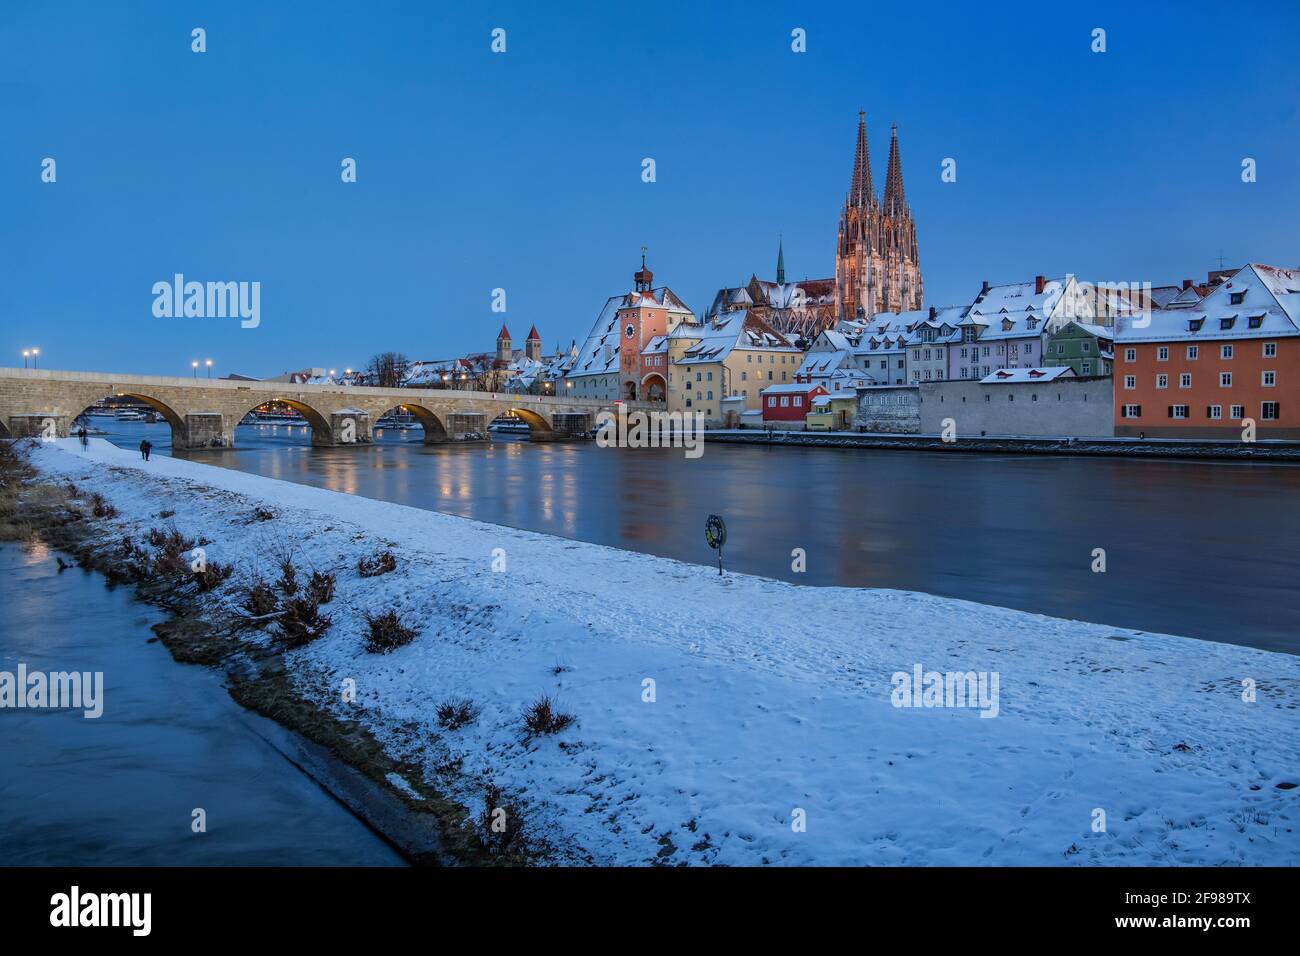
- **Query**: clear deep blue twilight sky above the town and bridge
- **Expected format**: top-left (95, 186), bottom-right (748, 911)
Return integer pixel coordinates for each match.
top-left (0, 0), bottom-right (1300, 376)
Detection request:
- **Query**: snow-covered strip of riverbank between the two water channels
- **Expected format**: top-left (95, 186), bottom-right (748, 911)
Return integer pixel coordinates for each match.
top-left (25, 441), bottom-right (1300, 865)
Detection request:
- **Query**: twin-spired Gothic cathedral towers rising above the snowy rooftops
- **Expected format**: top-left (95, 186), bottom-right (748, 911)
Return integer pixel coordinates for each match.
top-left (835, 111), bottom-right (922, 319)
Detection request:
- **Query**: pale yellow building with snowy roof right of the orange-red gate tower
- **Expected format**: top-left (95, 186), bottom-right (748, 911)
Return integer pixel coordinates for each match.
top-left (655, 310), bottom-right (803, 425)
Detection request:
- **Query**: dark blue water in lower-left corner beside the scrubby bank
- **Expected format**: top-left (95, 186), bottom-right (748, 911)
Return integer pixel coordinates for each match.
top-left (0, 544), bottom-right (403, 866)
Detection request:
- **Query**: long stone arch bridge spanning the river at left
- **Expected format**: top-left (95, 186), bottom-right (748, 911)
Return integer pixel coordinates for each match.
top-left (0, 368), bottom-right (655, 449)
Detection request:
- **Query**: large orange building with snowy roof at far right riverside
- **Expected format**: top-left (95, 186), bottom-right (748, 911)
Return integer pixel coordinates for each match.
top-left (1114, 264), bottom-right (1300, 440)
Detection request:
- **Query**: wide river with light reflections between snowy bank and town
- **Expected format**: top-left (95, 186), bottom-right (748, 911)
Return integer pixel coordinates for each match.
top-left (89, 419), bottom-right (1300, 653)
